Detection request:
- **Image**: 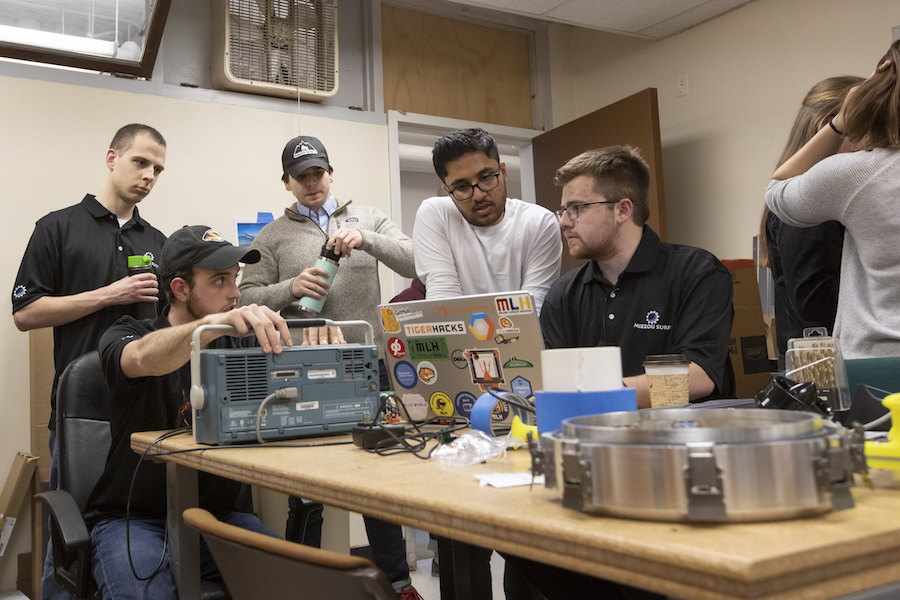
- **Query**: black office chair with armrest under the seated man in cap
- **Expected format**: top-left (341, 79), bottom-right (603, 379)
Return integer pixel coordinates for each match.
top-left (35, 351), bottom-right (228, 600)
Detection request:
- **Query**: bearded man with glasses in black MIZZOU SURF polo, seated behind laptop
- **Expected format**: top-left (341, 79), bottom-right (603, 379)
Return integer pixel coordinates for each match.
top-left (541, 146), bottom-right (734, 408)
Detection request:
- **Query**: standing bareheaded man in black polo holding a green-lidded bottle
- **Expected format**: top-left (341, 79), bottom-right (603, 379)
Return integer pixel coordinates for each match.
top-left (12, 124), bottom-right (166, 600)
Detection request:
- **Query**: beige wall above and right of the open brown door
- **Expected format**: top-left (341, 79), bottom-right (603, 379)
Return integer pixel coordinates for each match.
top-left (551, 0), bottom-right (900, 258)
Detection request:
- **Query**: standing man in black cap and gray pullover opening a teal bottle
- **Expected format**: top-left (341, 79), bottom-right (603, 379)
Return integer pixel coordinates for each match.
top-left (240, 136), bottom-right (419, 600)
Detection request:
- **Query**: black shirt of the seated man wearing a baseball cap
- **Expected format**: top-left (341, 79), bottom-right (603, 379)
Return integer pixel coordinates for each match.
top-left (85, 310), bottom-right (251, 526)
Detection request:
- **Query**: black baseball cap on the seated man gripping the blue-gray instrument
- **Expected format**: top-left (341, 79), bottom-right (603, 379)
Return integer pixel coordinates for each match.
top-left (159, 225), bottom-right (259, 281)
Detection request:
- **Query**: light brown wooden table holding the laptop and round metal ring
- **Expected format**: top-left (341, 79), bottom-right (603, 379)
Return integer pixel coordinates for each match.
top-left (131, 432), bottom-right (900, 600)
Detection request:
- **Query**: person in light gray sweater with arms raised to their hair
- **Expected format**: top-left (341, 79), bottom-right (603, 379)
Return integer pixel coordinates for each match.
top-left (766, 40), bottom-right (900, 358)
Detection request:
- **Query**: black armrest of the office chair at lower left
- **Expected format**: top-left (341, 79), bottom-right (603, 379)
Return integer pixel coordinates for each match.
top-left (34, 490), bottom-right (93, 598)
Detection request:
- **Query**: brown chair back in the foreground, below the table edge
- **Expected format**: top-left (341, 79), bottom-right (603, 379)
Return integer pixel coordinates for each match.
top-left (184, 508), bottom-right (399, 600)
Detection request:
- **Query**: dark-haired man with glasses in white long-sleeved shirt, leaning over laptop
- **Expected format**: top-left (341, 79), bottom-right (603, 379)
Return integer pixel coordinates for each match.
top-left (413, 129), bottom-right (562, 310)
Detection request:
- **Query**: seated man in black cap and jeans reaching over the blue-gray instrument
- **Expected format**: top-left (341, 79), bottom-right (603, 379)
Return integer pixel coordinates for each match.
top-left (85, 225), bottom-right (292, 598)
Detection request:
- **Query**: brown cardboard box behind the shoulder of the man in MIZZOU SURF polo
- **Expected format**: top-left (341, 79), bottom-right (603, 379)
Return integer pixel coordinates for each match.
top-left (722, 259), bottom-right (772, 398)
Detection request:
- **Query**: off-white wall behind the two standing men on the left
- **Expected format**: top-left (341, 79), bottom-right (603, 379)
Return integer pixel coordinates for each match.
top-left (0, 75), bottom-right (393, 592)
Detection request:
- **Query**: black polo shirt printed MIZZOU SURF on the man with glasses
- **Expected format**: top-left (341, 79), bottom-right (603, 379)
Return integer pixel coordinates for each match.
top-left (541, 225), bottom-right (734, 398)
